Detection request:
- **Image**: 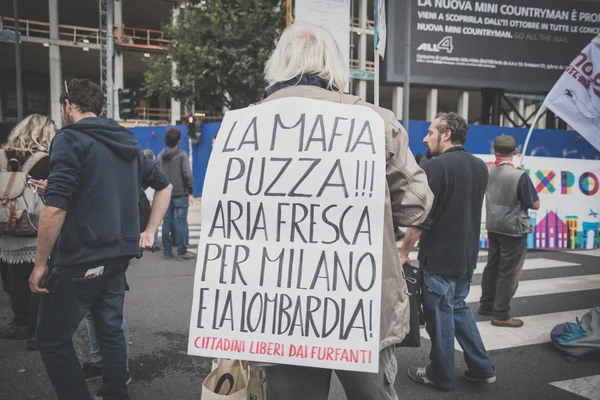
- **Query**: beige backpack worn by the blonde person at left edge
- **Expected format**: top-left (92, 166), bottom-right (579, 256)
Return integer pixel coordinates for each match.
top-left (0, 150), bottom-right (48, 236)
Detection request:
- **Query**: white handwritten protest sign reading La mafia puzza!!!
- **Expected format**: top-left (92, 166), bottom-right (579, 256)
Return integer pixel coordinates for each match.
top-left (188, 98), bottom-right (386, 372)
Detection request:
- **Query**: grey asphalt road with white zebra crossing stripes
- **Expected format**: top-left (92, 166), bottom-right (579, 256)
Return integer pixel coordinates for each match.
top-left (0, 247), bottom-right (600, 400)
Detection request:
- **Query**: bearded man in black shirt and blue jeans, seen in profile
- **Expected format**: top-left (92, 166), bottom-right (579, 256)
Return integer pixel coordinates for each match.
top-left (400, 113), bottom-right (496, 390)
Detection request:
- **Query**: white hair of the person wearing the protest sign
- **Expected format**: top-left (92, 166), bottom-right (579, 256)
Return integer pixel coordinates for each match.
top-left (265, 22), bottom-right (350, 92)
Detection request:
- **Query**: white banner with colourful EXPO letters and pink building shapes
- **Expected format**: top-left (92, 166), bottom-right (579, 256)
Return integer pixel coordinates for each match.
top-left (478, 155), bottom-right (600, 249)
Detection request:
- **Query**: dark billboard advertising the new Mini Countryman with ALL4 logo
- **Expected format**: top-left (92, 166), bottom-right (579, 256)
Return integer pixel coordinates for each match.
top-left (384, 0), bottom-right (600, 91)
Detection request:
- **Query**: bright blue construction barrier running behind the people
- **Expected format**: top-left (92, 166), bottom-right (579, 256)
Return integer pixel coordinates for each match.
top-left (131, 121), bottom-right (600, 197)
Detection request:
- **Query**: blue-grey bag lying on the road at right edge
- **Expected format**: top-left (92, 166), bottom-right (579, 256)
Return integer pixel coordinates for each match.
top-left (550, 307), bottom-right (600, 361)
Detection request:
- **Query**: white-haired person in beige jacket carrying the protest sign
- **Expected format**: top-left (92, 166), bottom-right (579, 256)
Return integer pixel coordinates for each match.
top-left (263, 23), bottom-right (433, 400)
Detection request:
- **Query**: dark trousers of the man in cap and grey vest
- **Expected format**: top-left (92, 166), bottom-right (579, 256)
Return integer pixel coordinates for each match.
top-left (479, 232), bottom-right (527, 321)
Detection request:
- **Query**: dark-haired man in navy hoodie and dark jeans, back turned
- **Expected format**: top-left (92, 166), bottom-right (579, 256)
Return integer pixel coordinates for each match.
top-left (29, 79), bottom-right (171, 400)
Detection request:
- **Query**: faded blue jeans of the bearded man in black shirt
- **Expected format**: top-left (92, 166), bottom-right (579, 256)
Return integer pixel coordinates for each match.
top-left (420, 262), bottom-right (494, 389)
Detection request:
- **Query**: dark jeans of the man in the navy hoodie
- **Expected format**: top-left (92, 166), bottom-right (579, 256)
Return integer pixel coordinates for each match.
top-left (36, 260), bottom-right (129, 400)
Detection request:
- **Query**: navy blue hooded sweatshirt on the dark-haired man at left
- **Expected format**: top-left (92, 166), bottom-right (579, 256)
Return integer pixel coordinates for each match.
top-left (46, 118), bottom-right (169, 266)
